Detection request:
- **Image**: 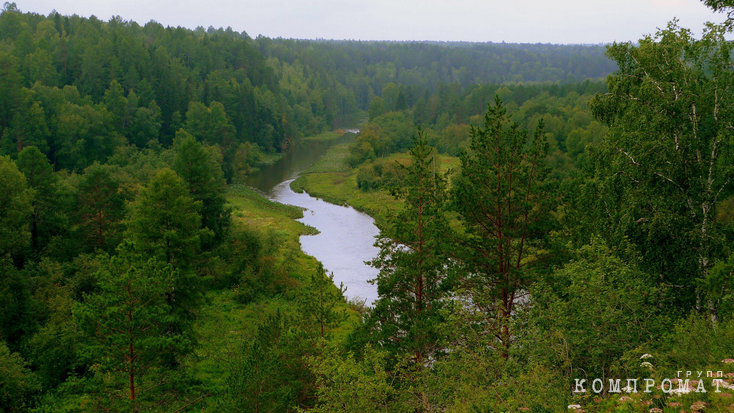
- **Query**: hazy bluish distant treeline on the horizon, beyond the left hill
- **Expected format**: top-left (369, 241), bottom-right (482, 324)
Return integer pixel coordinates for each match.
top-left (257, 37), bottom-right (617, 109)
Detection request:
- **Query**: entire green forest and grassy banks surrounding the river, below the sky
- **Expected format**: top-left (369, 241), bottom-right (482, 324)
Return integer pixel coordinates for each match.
top-left (0, 0), bottom-right (734, 413)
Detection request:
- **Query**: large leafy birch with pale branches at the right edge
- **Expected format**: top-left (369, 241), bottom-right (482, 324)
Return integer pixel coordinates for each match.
top-left (589, 22), bottom-right (734, 317)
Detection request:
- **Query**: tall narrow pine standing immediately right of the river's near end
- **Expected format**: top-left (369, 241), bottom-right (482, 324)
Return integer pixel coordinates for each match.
top-left (366, 130), bottom-right (451, 363)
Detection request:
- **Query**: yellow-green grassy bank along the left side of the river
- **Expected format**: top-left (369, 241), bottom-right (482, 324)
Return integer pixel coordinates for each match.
top-left (193, 185), bottom-right (358, 396)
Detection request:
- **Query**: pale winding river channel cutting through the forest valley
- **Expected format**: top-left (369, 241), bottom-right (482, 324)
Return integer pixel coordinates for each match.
top-left (247, 133), bottom-right (380, 305)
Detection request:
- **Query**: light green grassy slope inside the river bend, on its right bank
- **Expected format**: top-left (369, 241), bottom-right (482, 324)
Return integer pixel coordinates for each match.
top-left (291, 144), bottom-right (459, 227)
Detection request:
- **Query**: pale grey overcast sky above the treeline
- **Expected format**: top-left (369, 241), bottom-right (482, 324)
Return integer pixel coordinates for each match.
top-left (15, 0), bottom-right (723, 44)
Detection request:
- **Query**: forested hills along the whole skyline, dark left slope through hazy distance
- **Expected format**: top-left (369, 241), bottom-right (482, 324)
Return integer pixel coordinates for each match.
top-left (0, 3), bottom-right (615, 179)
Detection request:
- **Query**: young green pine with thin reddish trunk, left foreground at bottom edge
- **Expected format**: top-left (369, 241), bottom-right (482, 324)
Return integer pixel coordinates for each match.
top-left (74, 243), bottom-right (190, 411)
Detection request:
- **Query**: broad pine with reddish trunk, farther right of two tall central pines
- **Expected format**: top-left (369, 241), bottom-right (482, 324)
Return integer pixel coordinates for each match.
top-left (452, 97), bottom-right (553, 356)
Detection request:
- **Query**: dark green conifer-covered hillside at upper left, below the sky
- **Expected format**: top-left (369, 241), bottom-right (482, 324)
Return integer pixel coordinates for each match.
top-left (0, 3), bottom-right (356, 174)
